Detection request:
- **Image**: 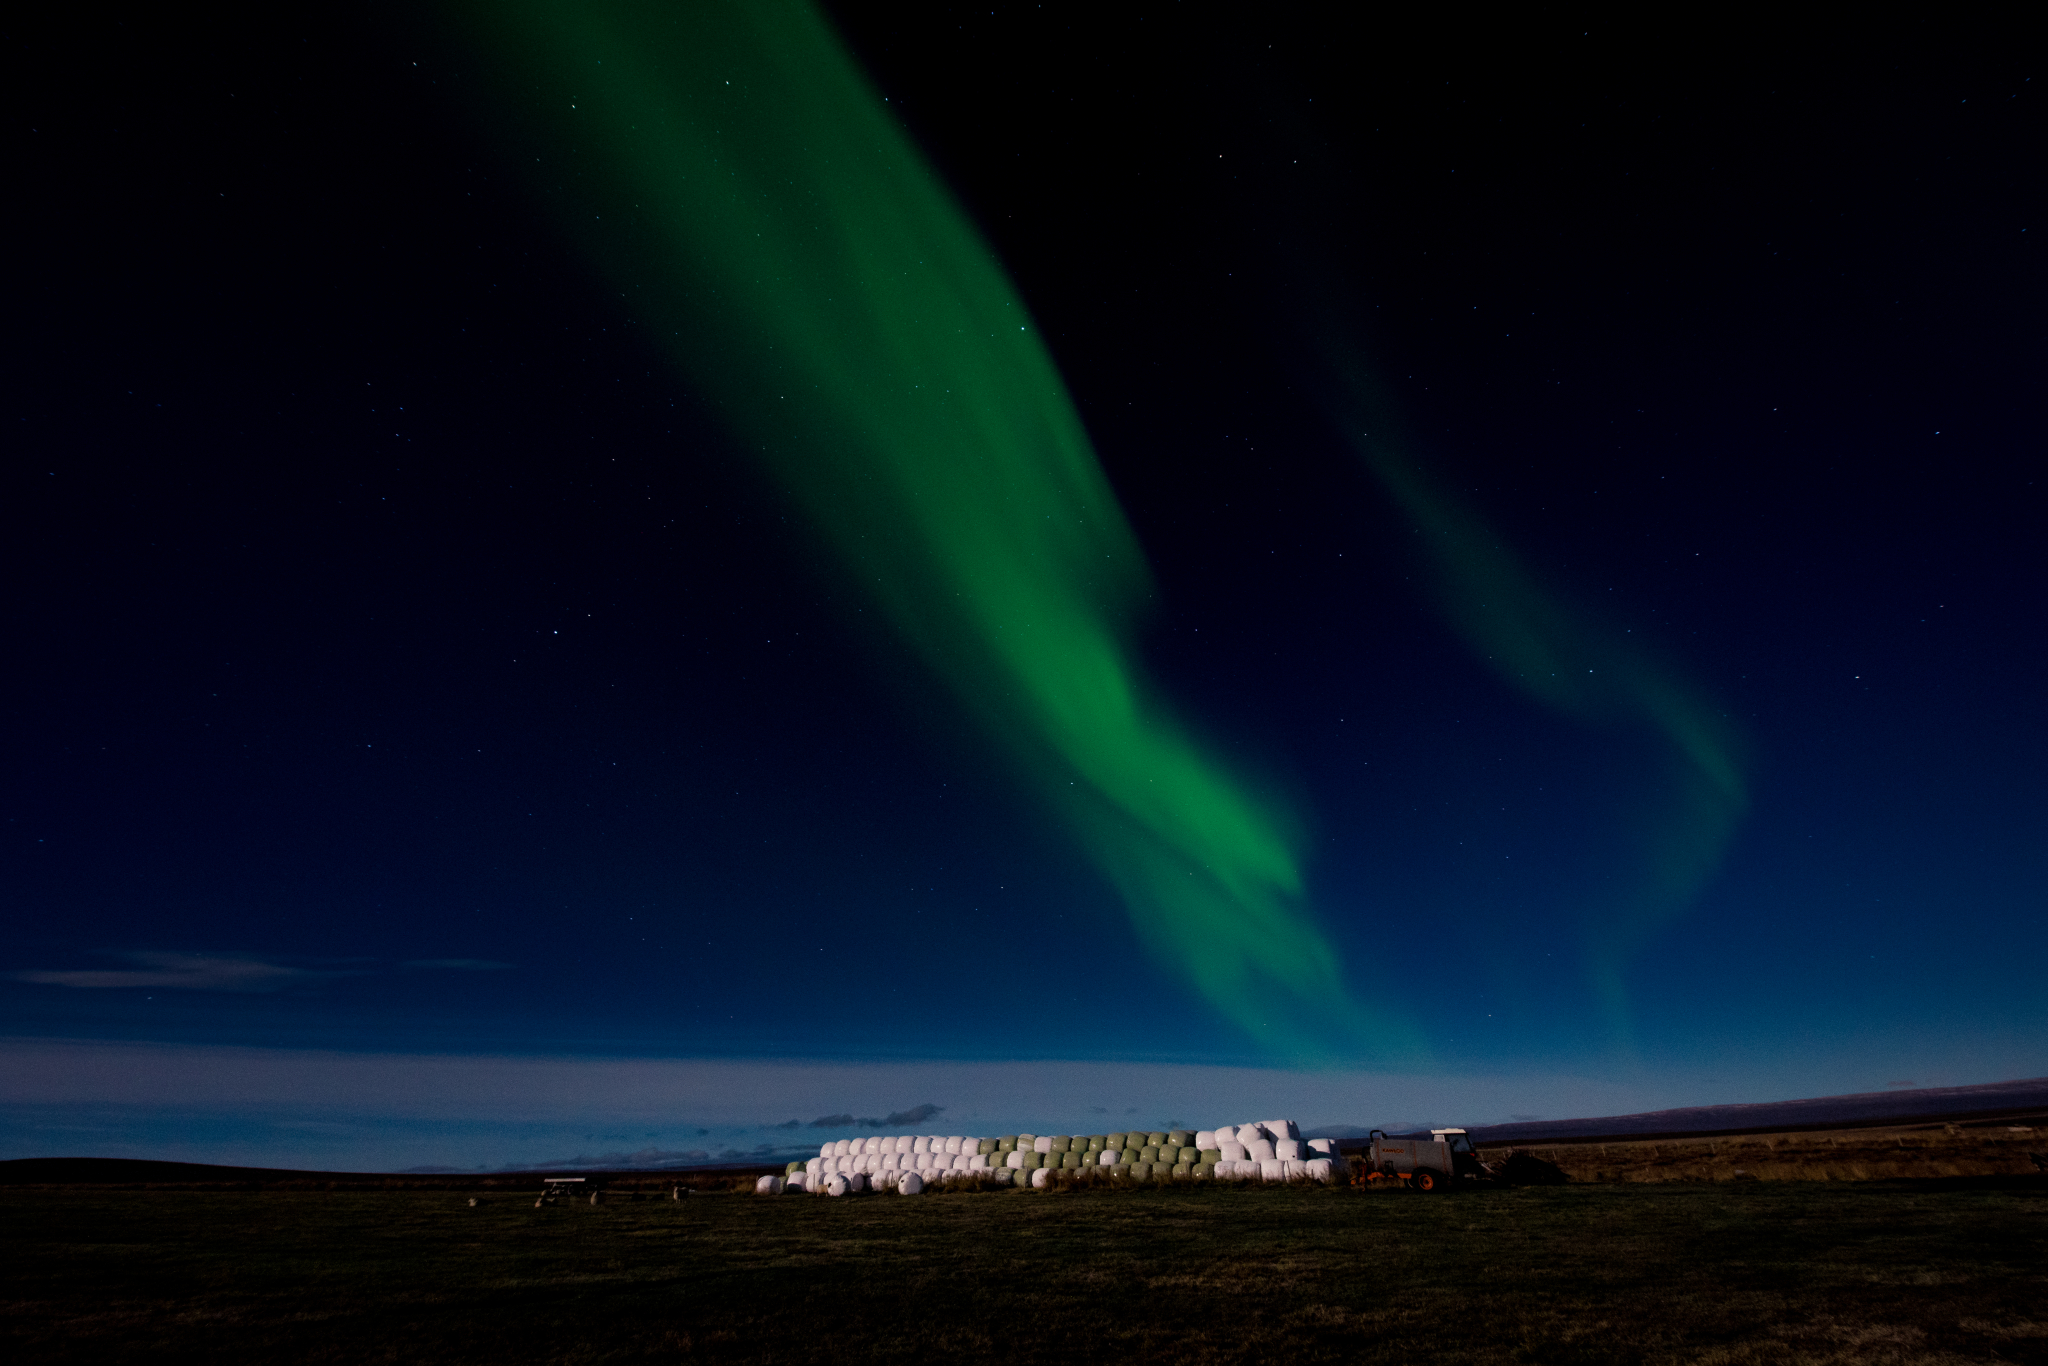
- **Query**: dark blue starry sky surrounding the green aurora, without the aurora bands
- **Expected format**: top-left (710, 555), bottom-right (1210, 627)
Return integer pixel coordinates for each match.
top-left (0, 6), bottom-right (2048, 1159)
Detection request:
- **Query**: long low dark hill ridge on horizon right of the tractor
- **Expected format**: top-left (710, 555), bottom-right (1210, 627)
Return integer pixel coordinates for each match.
top-left (1315, 1077), bottom-right (2048, 1143)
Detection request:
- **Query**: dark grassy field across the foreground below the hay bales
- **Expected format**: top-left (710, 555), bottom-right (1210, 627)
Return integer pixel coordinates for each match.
top-left (0, 1182), bottom-right (2048, 1366)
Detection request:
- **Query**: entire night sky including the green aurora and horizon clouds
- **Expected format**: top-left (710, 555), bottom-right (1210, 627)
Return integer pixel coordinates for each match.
top-left (0, 2), bottom-right (2048, 1165)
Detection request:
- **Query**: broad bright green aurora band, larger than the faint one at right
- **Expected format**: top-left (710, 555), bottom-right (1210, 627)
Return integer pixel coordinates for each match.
top-left (449, 0), bottom-right (1409, 1061)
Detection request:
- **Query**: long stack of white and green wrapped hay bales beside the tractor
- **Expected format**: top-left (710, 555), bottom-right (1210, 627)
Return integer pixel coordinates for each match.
top-left (762, 1120), bottom-right (1348, 1196)
